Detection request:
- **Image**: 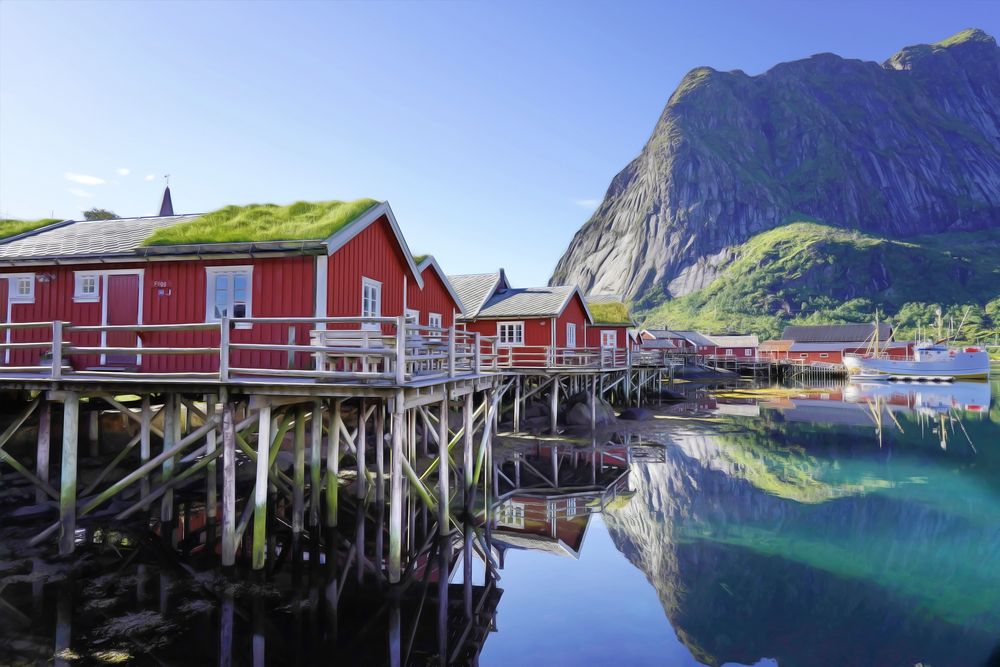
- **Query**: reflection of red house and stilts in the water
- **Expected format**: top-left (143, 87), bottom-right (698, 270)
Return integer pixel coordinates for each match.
top-left (493, 436), bottom-right (644, 567)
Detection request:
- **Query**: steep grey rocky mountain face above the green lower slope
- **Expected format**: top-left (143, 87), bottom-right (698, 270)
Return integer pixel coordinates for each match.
top-left (551, 30), bottom-right (1000, 305)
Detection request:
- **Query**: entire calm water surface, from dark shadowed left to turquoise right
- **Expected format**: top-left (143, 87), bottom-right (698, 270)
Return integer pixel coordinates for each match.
top-left (0, 382), bottom-right (1000, 667)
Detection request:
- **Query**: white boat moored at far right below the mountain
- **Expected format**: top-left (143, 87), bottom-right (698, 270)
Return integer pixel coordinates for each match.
top-left (844, 343), bottom-right (990, 382)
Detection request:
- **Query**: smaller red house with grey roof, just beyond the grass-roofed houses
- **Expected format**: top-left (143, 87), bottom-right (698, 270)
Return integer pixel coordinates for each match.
top-left (449, 269), bottom-right (600, 367)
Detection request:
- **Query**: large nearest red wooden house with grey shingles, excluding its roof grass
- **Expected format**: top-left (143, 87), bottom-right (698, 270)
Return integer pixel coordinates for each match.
top-left (0, 196), bottom-right (426, 372)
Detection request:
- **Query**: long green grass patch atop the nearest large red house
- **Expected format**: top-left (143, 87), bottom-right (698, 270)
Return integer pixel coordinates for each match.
top-left (143, 199), bottom-right (378, 246)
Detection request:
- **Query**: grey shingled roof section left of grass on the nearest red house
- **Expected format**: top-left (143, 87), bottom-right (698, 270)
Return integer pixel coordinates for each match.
top-left (0, 215), bottom-right (198, 260)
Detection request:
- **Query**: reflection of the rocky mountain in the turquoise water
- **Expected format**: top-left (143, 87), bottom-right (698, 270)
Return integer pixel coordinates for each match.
top-left (605, 434), bottom-right (1000, 666)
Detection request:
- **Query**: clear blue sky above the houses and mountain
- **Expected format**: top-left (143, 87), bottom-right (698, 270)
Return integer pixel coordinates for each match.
top-left (0, 0), bottom-right (1000, 286)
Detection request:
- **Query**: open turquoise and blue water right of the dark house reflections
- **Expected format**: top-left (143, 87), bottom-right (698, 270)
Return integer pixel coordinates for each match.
top-left (483, 385), bottom-right (1000, 666)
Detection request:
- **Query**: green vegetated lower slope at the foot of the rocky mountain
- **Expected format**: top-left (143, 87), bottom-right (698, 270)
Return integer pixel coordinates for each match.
top-left (643, 222), bottom-right (1000, 339)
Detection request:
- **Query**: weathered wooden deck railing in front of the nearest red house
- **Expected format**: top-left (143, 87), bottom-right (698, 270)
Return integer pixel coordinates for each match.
top-left (0, 317), bottom-right (497, 384)
